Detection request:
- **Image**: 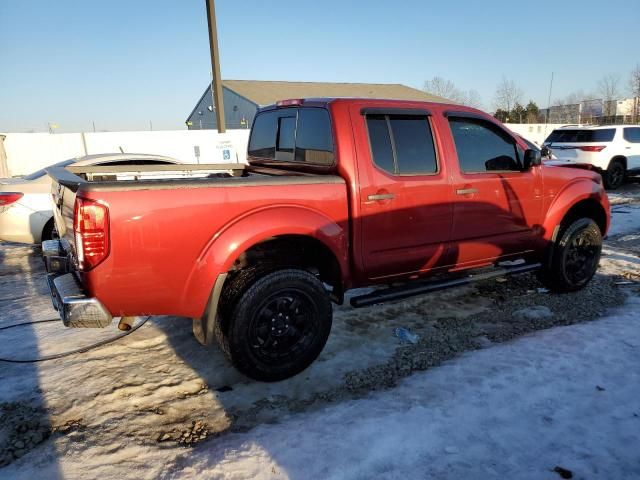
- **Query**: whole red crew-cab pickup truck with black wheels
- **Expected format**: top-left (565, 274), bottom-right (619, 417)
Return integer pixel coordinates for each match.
top-left (43, 99), bottom-right (610, 381)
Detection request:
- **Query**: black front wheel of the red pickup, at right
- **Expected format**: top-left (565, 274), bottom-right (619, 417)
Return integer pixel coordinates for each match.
top-left (540, 218), bottom-right (602, 292)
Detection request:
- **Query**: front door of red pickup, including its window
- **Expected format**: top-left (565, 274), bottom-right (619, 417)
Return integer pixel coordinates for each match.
top-left (447, 112), bottom-right (542, 267)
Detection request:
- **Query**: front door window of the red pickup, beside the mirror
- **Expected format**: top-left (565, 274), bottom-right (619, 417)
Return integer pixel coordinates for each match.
top-left (449, 117), bottom-right (521, 173)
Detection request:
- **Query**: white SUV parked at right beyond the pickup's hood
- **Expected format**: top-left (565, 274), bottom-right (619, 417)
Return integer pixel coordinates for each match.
top-left (544, 125), bottom-right (640, 190)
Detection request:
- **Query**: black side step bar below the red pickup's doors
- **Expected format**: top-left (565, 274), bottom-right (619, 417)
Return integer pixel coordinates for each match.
top-left (351, 263), bottom-right (542, 308)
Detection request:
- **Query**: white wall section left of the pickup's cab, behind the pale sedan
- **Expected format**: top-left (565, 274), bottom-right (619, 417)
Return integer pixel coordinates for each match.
top-left (4, 129), bottom-right (249, 176)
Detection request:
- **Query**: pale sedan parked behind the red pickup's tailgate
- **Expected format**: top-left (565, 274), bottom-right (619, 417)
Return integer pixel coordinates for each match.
top-left (0, 153), bottom-right (182, 243)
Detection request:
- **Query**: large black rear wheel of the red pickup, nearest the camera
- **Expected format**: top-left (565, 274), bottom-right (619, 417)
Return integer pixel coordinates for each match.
top-left (216, 269), bottom-right (332, 382)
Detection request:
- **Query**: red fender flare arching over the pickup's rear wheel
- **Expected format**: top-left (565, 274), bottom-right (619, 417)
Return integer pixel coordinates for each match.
top-left (181, 205), bottom-right (349, 312)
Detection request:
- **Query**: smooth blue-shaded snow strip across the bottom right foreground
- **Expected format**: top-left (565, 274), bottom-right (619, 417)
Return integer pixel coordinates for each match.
top-left (166, 297), bottom-right (640, 480)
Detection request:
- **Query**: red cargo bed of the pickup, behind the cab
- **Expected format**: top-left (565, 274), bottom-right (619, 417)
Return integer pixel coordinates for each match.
top-left (47, 164), bottom-right (348, 317)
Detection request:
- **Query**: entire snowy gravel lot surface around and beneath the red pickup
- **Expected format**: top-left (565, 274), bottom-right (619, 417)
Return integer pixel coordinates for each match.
top-left (0, 185), bottom-right (640, 479)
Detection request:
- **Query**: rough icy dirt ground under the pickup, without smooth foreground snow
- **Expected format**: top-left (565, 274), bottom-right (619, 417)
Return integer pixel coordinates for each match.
top-left (0, 184), bottom-right (640, 476)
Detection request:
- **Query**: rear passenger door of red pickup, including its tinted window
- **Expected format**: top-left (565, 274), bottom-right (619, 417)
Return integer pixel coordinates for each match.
top-left (351, 102), bottom-right (453, 279)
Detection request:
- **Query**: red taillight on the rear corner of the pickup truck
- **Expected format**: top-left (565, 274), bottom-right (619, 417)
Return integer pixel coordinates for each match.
top-left (73, 198), bottom-right (109, 271)
